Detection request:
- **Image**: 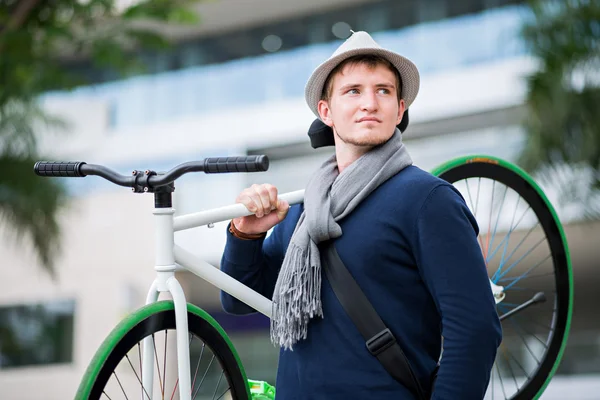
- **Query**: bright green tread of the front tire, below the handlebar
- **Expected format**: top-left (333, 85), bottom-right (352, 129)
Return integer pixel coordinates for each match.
top-left (75, 300), bottom-right (252, 400)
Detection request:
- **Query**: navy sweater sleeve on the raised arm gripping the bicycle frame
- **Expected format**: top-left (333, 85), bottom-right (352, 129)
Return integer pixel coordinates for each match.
top-left (221, 220), bottom-right (284, 315)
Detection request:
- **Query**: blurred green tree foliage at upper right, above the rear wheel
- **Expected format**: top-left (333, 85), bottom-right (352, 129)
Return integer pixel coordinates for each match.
top-left (519, 0), bottom-right (600, 216)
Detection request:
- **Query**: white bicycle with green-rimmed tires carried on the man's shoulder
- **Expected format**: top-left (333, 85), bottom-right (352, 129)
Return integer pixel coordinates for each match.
top-left (34, 156), bottom-right (573, 400)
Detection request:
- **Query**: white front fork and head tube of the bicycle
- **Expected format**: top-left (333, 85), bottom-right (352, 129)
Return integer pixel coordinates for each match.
top-left (142, 205), bottom-right (191, 400)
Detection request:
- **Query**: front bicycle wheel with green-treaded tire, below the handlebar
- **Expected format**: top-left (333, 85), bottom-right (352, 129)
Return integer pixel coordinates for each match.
top-left (76, 301), bottom-right (250, 400)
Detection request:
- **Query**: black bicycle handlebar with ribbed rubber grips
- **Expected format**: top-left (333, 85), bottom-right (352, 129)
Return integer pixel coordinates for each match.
top-left (33, 155), bottom-right (269, 189)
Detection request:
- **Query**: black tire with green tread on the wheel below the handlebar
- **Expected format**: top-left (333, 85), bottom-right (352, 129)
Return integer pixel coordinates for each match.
top-left (75, 301), bottom-right (250, 400)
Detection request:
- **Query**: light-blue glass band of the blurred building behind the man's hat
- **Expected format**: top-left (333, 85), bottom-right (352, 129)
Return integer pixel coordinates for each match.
top-left (49, 2), bottom-right (536, 129)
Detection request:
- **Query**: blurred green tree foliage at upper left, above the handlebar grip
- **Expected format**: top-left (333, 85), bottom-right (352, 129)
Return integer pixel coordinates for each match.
top-left (0, 0), bottom-right (198, 272)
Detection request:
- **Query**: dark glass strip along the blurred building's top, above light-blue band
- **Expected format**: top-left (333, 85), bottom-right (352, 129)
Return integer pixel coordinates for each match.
top-left (69, 0), bottom-right (524, 82)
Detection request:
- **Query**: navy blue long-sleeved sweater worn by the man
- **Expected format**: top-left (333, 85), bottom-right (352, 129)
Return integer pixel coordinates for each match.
top-left (221, 166), bottom-right (502, 400)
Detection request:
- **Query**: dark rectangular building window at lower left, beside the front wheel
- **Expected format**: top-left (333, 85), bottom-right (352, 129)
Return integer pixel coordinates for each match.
top-left (0, 299), bottom-right (75, 369)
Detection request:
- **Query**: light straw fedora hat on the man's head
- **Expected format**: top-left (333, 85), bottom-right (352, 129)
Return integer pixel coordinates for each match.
top-left (304, 31), bottom-right (420, 118)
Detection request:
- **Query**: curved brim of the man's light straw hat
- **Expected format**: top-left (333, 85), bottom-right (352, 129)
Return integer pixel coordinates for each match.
top-left (304, 47), bottom-right (420, 118)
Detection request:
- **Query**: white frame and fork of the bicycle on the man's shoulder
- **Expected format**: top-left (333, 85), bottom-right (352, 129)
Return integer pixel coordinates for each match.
top-left (142, 190), bottom-right (504, 400)
